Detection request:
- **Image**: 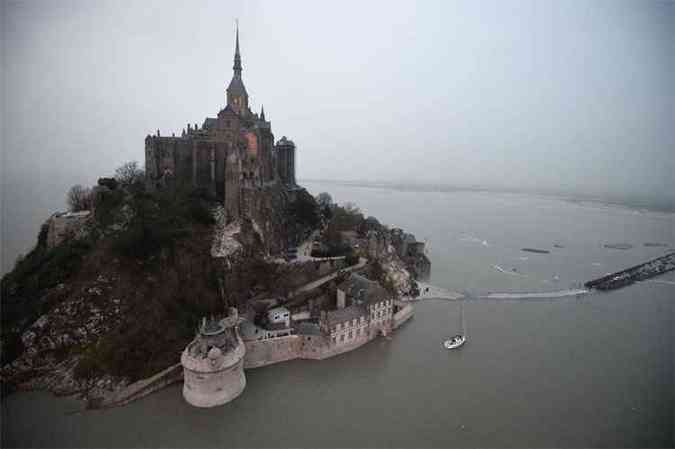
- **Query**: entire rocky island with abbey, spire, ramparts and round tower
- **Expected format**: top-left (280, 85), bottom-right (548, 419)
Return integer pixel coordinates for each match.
top-left (0, 26), bottom-right (431, 408)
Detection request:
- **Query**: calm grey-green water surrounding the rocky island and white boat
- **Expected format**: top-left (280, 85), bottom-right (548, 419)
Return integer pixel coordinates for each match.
top-left (2, 184), bottom-right (675, 447)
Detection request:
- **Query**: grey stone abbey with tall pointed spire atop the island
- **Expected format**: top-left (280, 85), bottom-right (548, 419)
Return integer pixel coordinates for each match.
top-left (145, 28), bottom-right (297, 221)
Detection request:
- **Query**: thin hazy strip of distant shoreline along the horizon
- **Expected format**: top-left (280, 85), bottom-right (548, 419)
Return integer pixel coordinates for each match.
top-left (301, 178), bottom-right (675, 214)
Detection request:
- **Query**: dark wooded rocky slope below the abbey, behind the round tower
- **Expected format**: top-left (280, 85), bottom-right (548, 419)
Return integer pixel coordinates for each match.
top-left (0, 178), bottom-right (318, 399)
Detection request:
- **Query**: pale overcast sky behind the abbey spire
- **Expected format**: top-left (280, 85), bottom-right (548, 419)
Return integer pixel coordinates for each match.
top-left (2, 0), bottom-right (675, 200)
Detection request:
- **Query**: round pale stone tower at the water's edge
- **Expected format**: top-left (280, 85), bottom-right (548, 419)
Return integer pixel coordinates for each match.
top-left (180, 307), bottom-right (246, 407)
